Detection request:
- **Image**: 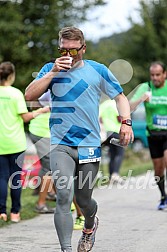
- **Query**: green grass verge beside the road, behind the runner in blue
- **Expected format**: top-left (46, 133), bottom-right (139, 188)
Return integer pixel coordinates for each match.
top-left (0, 149), bottom-right (152, 228)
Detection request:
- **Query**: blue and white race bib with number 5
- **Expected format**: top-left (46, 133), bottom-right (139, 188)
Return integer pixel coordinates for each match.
top-left (78, 146), bottom-right (101, 164)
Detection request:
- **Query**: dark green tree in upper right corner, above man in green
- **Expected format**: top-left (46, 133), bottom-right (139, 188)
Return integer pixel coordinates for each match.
top-left (120, 0), bottom-right (167, 91)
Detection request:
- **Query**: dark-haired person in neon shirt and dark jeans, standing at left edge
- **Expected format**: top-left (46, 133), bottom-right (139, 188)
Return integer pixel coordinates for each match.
top-left (0, 62), bottom-right (48, 222)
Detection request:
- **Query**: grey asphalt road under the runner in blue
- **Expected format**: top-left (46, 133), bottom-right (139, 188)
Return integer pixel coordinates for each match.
top-left (0, 173), bottom-right (167, 252)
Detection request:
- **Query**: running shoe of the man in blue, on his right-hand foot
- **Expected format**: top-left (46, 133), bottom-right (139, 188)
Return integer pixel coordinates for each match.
top-left (77, 216), bottom-right (99, 252)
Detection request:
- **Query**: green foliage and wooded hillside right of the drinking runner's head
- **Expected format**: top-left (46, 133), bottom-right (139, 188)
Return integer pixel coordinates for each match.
top-left (90, 0), bottom-right (167, 95)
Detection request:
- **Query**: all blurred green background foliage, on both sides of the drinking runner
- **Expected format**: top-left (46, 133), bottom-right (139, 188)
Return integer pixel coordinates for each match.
top-left (0, 0), bottom-right (167, 94)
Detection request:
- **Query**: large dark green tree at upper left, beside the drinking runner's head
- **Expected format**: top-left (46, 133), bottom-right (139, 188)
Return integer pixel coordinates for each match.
top-left (0, 0), bottom-right (105, 90)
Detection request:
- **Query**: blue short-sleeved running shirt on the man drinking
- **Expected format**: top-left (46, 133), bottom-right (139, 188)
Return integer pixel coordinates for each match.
top-left (36, 60), bottom-right (123, 147)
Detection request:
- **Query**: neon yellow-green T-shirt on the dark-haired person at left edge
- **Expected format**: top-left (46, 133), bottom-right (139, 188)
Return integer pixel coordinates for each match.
top-left (0, 86), bottom-right (28, 155)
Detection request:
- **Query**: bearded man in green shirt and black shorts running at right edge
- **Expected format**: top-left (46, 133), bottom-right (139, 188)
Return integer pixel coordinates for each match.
top-left (130, 61), bottom-right (167, 210)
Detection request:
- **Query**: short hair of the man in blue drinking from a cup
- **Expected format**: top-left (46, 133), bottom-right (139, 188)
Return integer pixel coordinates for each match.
top-left (59, 26), bottom-right (85, 45)
